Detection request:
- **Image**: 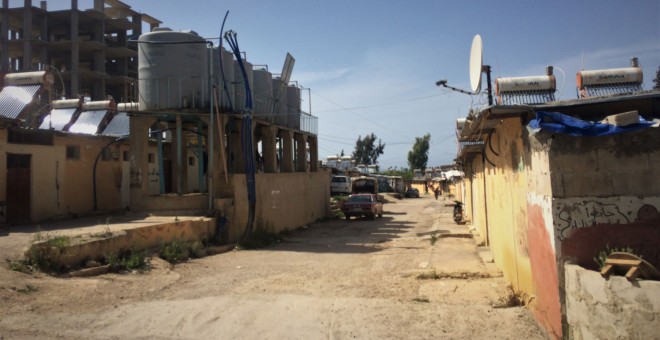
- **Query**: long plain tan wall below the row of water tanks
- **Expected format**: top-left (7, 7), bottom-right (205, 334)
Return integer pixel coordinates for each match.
top-left (221, 171), bottom-right (330, 242)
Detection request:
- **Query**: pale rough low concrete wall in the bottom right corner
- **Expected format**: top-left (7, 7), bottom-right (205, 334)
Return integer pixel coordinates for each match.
top-left (564, 264), bottom-right (660, 340)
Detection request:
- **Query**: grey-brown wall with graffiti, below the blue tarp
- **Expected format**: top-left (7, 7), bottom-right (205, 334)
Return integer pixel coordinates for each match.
top-left (550, 129), bottom-right (660, 250)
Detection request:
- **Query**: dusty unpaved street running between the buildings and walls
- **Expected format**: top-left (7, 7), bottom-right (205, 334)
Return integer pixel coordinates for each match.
top-left (0, 195), bottom-right (544, 339)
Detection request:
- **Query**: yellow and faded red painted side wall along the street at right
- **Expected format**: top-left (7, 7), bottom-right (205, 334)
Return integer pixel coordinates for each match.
top-left (479, 119), bottom-right (562, 338)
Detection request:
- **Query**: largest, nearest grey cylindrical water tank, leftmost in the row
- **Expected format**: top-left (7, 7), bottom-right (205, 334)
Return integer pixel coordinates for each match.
top-left (138, 28), bottom-right (209, 111)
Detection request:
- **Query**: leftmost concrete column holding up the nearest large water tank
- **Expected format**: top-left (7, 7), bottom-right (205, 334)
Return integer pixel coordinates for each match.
top-left (128, 116), bottom-right (156, 211)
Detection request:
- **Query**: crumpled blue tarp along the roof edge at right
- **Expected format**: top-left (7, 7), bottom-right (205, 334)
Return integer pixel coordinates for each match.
top-left (529, 111), bottom-right (653, 136)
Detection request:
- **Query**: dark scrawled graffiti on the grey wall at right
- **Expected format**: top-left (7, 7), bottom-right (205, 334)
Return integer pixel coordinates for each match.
top-left (556, 200), bottom-right (630, 240)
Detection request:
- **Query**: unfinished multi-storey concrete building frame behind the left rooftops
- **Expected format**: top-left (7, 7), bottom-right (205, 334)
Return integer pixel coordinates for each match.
top-left (0, 0), bottom-right (161, 102)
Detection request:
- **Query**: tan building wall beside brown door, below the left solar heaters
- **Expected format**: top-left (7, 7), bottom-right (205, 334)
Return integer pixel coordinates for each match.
top-left (0, 129), bottom-right (124, 222)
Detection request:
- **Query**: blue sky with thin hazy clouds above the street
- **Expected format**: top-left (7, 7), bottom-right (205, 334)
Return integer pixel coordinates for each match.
top-left (37, 0), bottom-right (660, 169)
